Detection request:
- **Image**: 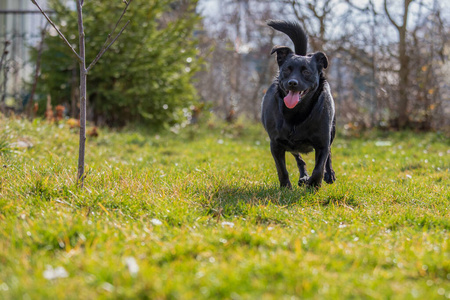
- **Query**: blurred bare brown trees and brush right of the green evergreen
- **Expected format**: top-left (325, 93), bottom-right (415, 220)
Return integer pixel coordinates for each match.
top-left (196, 0), bottom-right (450, 129)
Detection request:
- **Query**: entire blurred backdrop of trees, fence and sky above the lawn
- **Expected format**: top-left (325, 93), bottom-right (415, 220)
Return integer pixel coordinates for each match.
top-left (0, 0), bottom-right (450, 132)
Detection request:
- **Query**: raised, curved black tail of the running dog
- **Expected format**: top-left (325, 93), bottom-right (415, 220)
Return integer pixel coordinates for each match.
top-left (267, 20), bottom-right (308, 56)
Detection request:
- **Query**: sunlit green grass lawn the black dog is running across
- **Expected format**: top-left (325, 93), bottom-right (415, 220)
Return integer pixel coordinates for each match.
top-left (0, 119), bottom-right (450, 299)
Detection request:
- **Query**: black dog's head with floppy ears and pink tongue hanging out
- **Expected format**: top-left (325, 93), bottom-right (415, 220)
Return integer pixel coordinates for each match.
top-left (270, 46), bottom-right (328, 109)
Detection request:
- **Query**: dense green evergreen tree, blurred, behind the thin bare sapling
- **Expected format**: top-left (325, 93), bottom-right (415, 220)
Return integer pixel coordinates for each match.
top-left (34, 0), bottom-right (201, 126)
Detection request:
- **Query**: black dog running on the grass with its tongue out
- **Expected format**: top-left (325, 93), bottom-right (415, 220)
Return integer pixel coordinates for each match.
top-left (261, 20), bottom-right (336, 188)
